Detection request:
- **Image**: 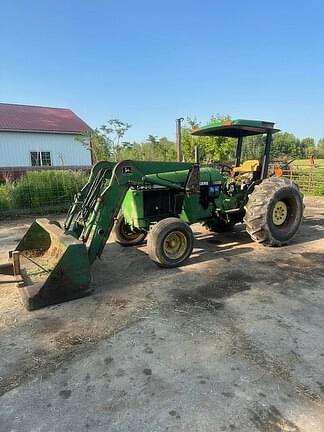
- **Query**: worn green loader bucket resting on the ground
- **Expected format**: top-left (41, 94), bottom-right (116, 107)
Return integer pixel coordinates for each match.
top-left (11, 219), bottom-right (92, 310)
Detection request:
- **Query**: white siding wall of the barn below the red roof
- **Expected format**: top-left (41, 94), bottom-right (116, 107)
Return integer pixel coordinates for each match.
top-left (0, 131), bottom-right (91, 167)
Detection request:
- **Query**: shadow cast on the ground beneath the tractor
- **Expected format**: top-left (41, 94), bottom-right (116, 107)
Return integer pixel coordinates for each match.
top-left (92, 213), bottom-right (324, 290)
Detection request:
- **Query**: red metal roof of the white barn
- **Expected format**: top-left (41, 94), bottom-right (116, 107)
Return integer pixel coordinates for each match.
top-left (0, 103), bottom-right (90, 133)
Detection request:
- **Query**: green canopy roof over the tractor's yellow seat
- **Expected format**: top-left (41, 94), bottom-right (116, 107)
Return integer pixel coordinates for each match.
top-left (192, 119), bottom-right (279, 138)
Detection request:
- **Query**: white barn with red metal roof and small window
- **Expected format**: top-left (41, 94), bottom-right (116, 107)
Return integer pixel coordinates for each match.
top-left (0, 103), bottom-right (91, 177)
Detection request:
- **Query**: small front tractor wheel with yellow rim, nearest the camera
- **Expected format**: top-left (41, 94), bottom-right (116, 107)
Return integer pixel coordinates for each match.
top-left (147, 218), bottom-right (194, 267)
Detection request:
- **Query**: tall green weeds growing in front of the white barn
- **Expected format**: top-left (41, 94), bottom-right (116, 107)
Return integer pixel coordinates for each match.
top-left (0, 170), bottom-right (88, 214)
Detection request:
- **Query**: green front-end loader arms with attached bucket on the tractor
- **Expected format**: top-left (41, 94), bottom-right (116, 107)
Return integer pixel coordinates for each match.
top-left (0, 161), bottom-right (192, 310)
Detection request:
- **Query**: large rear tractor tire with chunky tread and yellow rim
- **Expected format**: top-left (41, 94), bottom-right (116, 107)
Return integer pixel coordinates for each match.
top-left (244, 177), bottom-right (304, 246)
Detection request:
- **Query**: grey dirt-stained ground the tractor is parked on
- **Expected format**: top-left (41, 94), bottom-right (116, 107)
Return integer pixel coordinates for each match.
top-left (0, 198), bottom-right (324, 432)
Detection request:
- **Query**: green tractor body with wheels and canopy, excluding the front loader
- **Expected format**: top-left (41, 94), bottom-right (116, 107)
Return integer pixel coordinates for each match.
top-left (115, 120), bottom-right (304, 267)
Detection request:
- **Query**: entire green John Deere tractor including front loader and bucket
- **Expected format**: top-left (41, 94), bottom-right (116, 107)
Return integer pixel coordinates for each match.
top-left (0, 120), bottom-right (304, 309)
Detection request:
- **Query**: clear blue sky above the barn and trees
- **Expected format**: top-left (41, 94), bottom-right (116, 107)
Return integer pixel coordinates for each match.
top-left (0, 0), bottom-right (324, 140)
